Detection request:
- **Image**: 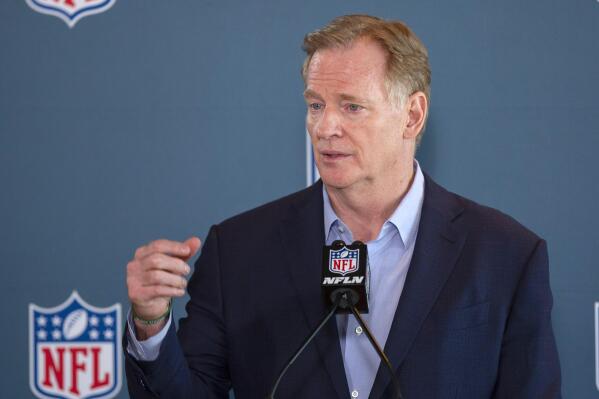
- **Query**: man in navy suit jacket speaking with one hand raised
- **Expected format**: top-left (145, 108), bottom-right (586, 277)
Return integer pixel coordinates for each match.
top-left (125, 16), bottom-right (560, 399)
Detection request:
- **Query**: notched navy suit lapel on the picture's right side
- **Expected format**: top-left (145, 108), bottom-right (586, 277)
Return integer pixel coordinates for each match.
top-left (370, 176), bottom-right (465, 399)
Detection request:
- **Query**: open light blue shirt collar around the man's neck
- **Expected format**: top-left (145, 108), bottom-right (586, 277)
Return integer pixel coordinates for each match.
top-left (322, 160), bottom-right (424, 246)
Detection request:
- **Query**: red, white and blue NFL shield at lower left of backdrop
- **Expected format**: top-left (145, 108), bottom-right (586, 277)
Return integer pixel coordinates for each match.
top-left (29, 291), bottom-right (121, 399)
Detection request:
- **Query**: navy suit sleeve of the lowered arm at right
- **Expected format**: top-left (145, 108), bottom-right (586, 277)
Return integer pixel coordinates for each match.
top-left (493, 240), bottom-right (561, 399)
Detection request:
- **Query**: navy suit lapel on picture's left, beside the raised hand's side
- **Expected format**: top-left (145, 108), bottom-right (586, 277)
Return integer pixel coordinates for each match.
top-left (281, 182), bottom-right (349, 398)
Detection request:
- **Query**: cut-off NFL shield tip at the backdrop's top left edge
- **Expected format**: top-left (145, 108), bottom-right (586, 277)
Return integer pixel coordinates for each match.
top-left (25, 0), bottom-right (116, 28)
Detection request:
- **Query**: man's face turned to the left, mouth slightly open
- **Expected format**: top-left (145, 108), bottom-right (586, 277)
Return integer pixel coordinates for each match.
top-left (304, 39), bottom-right (413, 189)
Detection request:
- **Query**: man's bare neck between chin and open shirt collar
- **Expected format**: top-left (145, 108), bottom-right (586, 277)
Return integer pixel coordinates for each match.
top-left (326, 165), bottom-right (416, 242)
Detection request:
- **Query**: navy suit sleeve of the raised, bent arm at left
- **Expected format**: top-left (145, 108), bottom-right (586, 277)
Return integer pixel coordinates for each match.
top-left (124, 226), bottom-right (231, 399)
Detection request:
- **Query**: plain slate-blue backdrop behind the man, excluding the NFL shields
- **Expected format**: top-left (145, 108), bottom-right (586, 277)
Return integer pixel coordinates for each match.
top-left (0, 0), bottom-right (599, 399)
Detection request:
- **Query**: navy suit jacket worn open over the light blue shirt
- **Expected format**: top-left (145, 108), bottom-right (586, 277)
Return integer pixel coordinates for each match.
top-left (125, 176), bottom-right (561, 399)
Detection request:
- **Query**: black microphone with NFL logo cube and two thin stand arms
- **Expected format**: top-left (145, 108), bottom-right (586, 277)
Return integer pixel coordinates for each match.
top-left (266, 240), bottom-right (403, 399)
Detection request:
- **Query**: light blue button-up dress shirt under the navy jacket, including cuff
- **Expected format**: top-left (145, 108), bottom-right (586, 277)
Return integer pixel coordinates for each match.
top-left (127, 161), bottom-right (424, 398)
